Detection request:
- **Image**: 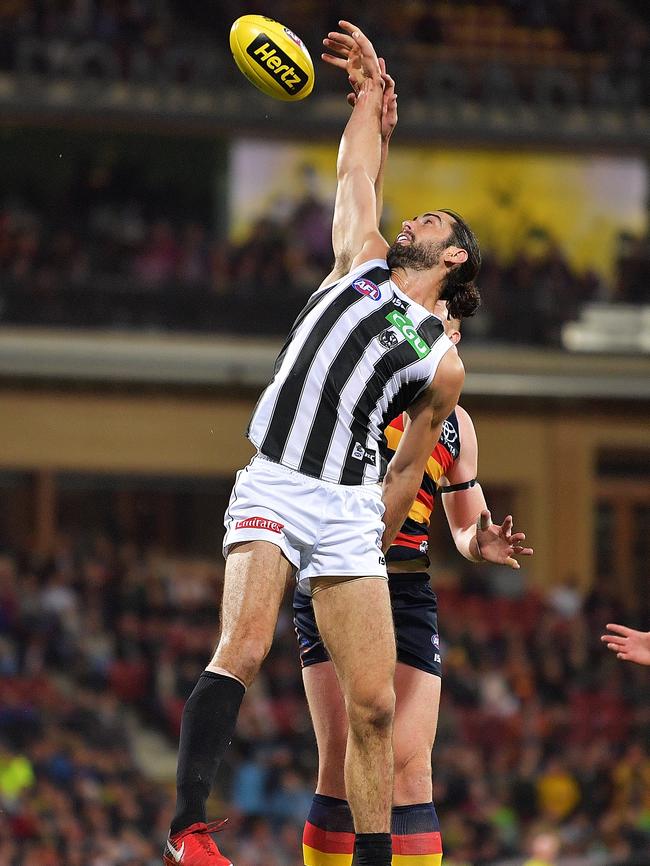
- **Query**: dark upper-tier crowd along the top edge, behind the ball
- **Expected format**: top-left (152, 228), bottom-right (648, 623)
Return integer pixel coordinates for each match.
top-left (0, 0), bottom-right (650, 106)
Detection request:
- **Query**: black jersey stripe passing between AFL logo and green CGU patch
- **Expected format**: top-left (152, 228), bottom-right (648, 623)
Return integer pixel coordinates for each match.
top-left (299, 297), bottom-right (395, 475)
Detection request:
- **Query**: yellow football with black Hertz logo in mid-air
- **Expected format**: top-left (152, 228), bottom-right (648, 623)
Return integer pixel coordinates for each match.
top-left (230, 15), bottom-right (314, 102)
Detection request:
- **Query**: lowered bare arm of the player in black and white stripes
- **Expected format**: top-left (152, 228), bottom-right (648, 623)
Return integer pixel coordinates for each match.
top-left (382, 349), bottom-right (465, 551)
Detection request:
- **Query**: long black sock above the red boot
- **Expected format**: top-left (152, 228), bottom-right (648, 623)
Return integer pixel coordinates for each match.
top-left (171, 671), bottom-right (246, 835)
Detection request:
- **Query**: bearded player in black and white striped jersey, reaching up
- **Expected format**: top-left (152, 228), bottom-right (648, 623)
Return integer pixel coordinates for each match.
top-left (164, 22), bottom-right (480, 866)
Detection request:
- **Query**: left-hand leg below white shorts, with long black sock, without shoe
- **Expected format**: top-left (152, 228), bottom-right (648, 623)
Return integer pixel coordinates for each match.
top-left (172, 541), bottom-right (292, 835)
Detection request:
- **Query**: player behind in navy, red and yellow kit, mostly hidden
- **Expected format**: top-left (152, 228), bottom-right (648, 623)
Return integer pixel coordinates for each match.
top-left (294, 303), bottom-right (533, 866)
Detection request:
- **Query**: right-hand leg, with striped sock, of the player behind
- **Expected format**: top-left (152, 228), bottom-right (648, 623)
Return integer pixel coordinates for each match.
top-left (392, 662), bottom-right (442, 866)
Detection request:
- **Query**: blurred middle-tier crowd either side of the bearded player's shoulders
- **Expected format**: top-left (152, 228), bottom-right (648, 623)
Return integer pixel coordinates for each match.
top-left (0, 197), bottom-right (650, 345)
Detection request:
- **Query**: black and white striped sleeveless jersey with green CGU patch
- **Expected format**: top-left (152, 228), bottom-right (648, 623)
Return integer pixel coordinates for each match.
top-left (247, 259), bottom-right (452, 484)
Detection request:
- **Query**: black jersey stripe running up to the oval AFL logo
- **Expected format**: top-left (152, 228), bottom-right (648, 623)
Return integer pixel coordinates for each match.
top-left (260, 267), bottom-right (388, 462)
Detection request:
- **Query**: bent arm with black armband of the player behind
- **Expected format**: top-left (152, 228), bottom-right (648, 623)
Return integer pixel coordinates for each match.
top-left (440, 406), bottom-right (533, 568)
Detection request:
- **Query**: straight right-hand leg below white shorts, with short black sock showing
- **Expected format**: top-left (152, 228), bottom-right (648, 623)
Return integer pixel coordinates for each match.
top-left (312, 577), bottom-right (395, 866)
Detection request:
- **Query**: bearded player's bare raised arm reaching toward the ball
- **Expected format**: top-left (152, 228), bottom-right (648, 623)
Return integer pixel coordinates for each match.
top-left (323, 21), bottom-right (388, 282)
